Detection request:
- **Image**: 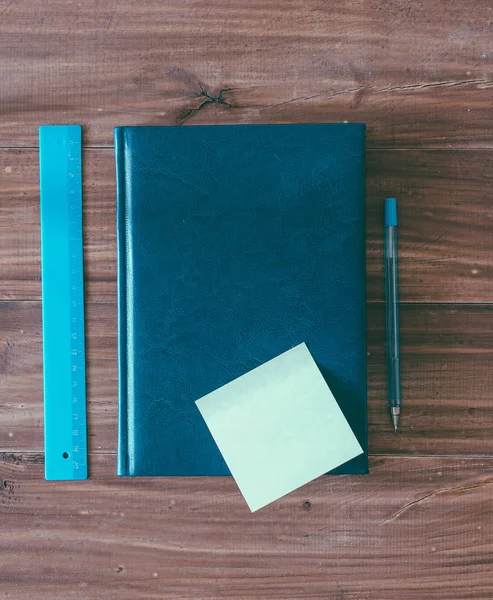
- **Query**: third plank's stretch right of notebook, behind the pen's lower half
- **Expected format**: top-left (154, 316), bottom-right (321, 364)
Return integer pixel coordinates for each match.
top-left (367, 304), bottom-right (493, 455)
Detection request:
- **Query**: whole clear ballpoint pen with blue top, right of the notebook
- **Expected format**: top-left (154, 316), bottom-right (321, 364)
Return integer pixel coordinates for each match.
top-left (384, 198), bottom-right (402, 431)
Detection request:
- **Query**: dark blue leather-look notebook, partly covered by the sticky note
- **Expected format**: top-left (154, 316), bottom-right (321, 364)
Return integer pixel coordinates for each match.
top-left (115, 124), bottom-right (368, 475)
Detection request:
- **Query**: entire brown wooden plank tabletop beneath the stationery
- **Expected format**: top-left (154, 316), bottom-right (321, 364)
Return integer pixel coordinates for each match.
top-left (0, 0), bottom-right (493, 600)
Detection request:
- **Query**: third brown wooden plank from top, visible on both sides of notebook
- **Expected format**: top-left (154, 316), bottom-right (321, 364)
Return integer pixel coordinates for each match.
top-left (0, 302), bottom-right (493, 456)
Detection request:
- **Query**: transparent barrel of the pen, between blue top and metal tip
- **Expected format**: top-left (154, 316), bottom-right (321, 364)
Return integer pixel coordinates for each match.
top-left (384, 227), bottom-right (401, 407)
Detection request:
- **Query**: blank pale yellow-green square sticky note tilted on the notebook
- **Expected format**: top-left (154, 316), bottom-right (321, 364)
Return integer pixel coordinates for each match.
top-left (196, 344), bottom-right (363, 512)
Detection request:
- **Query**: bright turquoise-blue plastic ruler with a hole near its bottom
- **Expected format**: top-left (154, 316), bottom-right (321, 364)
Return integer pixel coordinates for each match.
top-left (39, 125), bottom-right (87, 480)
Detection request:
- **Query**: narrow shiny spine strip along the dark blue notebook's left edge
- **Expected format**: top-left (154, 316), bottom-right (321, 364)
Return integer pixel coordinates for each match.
top-left (114, 127), bottom-right (129, 475)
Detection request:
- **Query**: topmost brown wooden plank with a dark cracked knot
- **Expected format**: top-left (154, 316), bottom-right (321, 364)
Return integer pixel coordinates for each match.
top-left (0, 0), bottom-right (493, 148)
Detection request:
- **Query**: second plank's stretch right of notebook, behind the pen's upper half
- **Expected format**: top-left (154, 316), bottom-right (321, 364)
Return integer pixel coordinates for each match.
top-left (367, 151), bottom-right (493, 302)
